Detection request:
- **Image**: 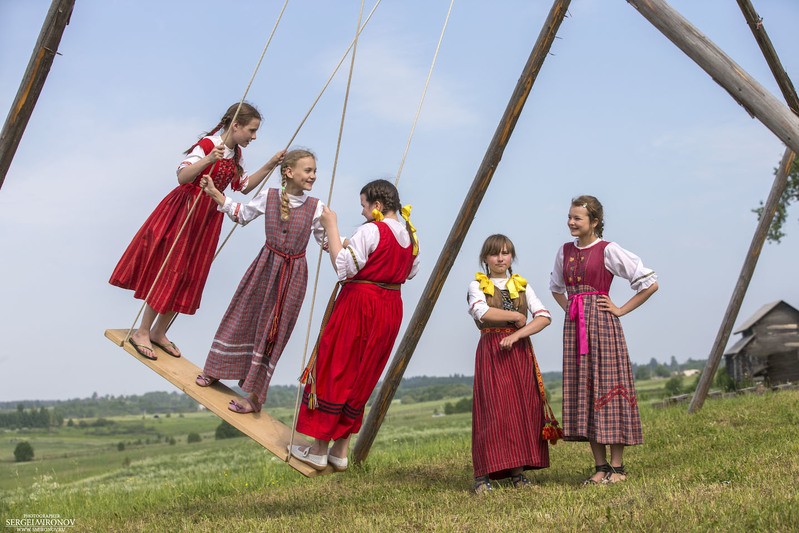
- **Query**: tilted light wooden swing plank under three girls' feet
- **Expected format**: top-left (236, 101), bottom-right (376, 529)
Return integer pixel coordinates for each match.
top-left (105, 329), bottom-right (333, 477)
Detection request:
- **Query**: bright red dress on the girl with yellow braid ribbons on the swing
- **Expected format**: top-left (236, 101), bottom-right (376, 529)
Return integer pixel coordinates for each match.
top-left (297, 222), bottom-right (414, 440)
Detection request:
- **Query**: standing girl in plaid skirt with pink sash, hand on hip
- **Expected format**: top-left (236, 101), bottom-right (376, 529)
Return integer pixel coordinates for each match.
top-left (549, 196), bottom-right (658, 484)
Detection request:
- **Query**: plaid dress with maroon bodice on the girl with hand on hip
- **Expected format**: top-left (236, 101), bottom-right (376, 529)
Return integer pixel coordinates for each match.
top-left (563, 241), bottom-right (644, 446)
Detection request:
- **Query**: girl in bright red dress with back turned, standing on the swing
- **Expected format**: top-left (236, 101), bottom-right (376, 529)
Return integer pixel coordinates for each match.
top-left (290, 180), bottom-right (419, 470)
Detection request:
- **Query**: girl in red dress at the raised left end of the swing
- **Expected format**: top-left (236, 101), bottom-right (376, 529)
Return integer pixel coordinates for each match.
top-left (109, 103), bottom-right (284, 360)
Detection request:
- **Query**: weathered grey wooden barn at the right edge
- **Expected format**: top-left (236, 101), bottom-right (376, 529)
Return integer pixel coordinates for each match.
top-left (724, 300), bottom-right (799, 385)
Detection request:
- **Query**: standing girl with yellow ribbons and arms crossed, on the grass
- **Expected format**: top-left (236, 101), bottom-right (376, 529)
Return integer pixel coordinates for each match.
top-left (467, 235), bottom-right (552, 494)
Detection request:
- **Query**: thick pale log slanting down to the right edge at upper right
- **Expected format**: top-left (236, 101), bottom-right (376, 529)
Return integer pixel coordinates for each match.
top-left (627, 0), bottom-right (799, 152)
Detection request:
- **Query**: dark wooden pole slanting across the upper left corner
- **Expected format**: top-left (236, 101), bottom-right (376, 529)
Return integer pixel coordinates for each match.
top-left (0, 0), bottom-right (75, 188)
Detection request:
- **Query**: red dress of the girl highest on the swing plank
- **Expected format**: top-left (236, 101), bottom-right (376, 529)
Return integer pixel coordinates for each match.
top-left (109, 137), bottom-right (241, 315)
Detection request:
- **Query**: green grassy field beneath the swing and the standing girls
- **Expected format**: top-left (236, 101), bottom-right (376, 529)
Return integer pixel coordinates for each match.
top-left (0, 384), bottom-right (799, 531)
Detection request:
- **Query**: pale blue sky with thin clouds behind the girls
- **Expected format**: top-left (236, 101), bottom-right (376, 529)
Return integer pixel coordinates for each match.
top-left (0, 0), bottom-right (799, 401)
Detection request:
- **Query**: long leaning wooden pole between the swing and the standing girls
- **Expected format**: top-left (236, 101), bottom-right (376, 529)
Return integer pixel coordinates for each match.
top-left (353, 0), bottom-right (571, 463)
